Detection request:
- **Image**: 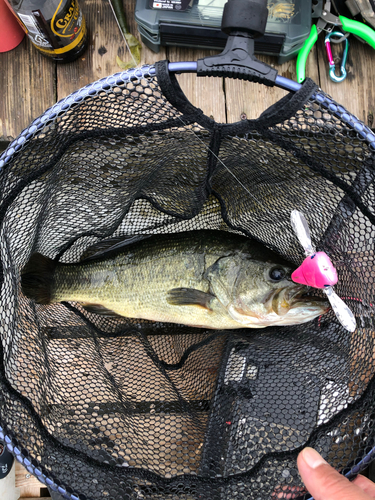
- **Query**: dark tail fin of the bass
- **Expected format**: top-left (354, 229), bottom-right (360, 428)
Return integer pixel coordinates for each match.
top-left (21, 253), bottom-right (57, 304)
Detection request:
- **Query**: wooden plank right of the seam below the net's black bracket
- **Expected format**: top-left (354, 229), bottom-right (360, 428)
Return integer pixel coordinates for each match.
top-left (225, 48), bottom-right (319, 123)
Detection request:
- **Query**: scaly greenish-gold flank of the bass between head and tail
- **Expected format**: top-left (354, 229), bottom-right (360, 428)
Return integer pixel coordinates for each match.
top-left (53, 231), bottom-right (247, 328)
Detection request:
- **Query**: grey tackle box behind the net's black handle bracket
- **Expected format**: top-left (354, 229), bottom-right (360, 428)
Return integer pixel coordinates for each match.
top-left (135, 0), bottom-right (323, 64)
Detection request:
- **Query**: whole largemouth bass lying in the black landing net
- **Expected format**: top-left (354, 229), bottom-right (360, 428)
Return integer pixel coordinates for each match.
top-left (21, 230), bottom-right (329, 329)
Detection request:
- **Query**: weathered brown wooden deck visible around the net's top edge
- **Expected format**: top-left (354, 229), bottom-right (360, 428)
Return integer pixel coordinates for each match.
top-left (0, 0), bottom-right (375, 141)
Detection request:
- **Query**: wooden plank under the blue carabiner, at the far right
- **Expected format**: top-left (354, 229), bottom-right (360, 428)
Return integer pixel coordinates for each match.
top-left (317, 35), bottom-right (375, 127)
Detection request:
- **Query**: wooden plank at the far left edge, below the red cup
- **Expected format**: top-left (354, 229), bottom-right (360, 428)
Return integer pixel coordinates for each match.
top-left (0, 37), bottom-right (56, 141)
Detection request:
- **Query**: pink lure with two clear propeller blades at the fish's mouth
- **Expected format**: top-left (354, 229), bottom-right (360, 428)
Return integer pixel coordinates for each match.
top-left (290, 210), bottom-right (357, 332)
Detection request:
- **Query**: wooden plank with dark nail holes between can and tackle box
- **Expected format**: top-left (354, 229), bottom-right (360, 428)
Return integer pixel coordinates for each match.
top-left (57, 0), bottom-right (165, 100)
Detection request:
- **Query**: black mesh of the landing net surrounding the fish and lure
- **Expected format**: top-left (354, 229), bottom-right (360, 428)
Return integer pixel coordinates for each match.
top-left (0, 64), bottom-right (375, 500)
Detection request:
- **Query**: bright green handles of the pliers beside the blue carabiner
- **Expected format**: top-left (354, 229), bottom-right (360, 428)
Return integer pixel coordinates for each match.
top-left (297, 0), bottom-right (375, 83)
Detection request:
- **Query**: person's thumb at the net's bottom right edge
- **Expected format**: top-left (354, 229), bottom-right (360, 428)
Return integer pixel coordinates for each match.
top-left (297, 448), bottom-right (373, 500)
